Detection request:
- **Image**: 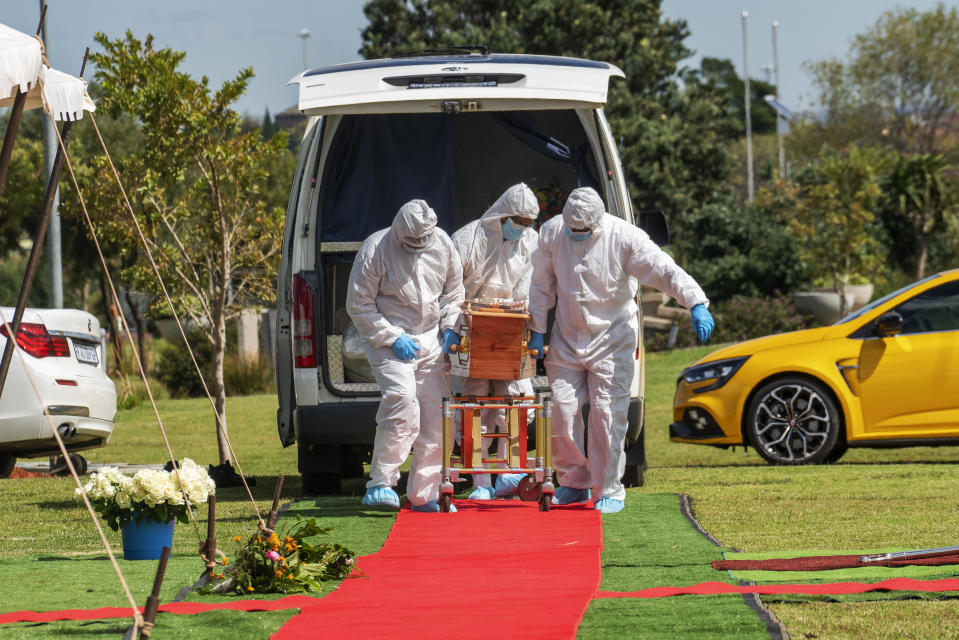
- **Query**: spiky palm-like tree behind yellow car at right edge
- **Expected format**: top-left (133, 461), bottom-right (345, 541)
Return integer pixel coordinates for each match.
top-left (883, 154), bottom-right (959, 278)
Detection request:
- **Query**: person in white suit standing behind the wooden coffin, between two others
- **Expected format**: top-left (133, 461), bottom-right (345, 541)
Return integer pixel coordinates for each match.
top-left (451, 183), bottom-right (539, 500)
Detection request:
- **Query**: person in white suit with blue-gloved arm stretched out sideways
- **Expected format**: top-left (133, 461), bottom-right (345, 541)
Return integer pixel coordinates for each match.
top-left (529, 187), bottom-right (713, 513)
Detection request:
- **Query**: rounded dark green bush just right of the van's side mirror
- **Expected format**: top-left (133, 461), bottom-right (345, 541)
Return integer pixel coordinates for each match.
top-left (683, 198), bottom-right (803, 303)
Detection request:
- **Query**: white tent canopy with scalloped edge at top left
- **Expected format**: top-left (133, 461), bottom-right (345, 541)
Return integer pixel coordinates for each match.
top-left (0, 24), bottom-right (96, 120)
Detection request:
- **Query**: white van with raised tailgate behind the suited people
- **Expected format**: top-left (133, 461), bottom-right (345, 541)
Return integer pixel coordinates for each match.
top-left (276, 46), bottom-right (665, 494)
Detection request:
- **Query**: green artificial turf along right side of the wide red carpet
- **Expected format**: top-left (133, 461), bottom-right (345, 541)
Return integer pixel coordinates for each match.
top-left (577, 490), bottom-right (775, 640)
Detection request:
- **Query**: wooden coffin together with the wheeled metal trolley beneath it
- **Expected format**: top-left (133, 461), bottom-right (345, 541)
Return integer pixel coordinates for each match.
top-left (439, 298), bottom-right (555, 513)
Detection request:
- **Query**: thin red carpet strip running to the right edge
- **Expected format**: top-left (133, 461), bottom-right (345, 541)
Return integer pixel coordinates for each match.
top-left (596, 578), bottom-right (959, 598)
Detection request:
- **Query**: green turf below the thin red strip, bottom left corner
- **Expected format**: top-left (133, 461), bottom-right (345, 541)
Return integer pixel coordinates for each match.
top-left (0, 609), bottom-right (298, 640)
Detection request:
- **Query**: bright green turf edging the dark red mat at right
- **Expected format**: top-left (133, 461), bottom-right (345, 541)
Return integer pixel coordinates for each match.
top-left (723, 549), bottom-right (959, 584)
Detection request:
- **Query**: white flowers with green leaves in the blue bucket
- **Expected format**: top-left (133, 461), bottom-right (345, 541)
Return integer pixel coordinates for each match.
top-left (74, 458), bottom-right (216, 531)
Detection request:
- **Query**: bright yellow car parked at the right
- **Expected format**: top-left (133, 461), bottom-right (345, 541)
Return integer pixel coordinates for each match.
top-left (669, 269), bottom-right (959, 465)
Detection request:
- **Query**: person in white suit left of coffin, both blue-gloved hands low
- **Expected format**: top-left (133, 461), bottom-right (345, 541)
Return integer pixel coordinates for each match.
top-left (346, 200), bottom-right (463, 512)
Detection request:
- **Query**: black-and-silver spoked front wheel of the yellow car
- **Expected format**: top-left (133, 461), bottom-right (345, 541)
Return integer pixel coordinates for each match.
top-left (746, 376), bottom-right (842, 465)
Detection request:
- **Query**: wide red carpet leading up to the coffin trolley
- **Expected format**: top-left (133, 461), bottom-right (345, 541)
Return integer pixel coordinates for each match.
top-left (273, 500), bottom-right (603, 640)
